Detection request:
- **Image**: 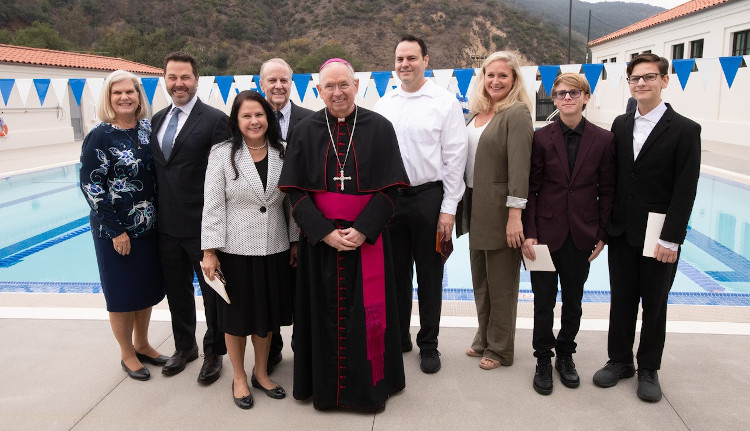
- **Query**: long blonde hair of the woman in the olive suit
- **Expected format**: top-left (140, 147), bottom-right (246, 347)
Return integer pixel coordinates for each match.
top-left (469, 51), bottom-right (531, 114)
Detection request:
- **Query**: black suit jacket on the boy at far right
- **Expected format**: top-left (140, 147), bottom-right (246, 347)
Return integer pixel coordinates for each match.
top-left (607, 104), bottom-right (701, 247)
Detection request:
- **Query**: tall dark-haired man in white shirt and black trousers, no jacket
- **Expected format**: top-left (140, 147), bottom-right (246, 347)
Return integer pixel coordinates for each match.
top-left (374, 35), bottom-right (468, 373)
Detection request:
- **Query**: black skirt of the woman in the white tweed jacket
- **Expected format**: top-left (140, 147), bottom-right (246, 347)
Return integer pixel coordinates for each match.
top-left (216, 250), bottom-right (293, 337)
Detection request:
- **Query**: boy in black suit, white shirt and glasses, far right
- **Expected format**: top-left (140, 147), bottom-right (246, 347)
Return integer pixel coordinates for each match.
top-left (594, 54), bottom-right (701, 402)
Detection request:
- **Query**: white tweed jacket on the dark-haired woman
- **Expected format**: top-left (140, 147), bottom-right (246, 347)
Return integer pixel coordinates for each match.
top-left (206, 141), bottom-right (299, 256)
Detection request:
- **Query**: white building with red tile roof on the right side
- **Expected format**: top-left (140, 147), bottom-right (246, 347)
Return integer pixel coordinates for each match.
top-left (586, 0), bottom-right (750, 147)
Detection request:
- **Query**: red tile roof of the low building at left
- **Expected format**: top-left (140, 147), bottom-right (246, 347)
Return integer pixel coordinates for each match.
top-left (0, 44), bottom-right (164, 75)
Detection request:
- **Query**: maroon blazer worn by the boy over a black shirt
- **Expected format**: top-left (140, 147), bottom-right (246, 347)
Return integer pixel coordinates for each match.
top-left (523, 118), bottom-right (615, 251)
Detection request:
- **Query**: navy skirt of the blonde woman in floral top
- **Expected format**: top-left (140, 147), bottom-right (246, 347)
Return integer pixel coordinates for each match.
top-left (92, 231), bottom-right (164, 312)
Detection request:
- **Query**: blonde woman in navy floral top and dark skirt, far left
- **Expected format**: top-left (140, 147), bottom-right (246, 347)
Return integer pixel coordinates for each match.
top-left (80, 70), bottom-right (169, 380)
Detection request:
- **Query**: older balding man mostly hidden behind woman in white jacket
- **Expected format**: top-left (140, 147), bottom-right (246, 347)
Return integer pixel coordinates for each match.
top-left (260, 58), bottom-right (314, 374)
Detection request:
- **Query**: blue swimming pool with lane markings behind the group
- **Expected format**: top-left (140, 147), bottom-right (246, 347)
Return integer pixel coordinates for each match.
top-left (0, 165), bottom-right (750, 306)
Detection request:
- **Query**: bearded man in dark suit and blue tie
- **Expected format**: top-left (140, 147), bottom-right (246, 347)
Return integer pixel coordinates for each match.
top-left (151, 52), bottom-right (229, 384)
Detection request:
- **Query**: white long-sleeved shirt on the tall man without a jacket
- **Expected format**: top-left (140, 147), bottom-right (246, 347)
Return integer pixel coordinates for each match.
top-left (374, 79), bottom-right (468, 214)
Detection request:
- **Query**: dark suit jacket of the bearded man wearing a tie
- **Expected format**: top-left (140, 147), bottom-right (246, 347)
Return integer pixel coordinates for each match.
top-left (151, 99), bottom-right (230, 238)
